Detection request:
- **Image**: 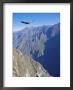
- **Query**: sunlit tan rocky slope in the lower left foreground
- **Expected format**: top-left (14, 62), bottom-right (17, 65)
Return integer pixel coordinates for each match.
top-left (13, 49), bottom-right (50, 77)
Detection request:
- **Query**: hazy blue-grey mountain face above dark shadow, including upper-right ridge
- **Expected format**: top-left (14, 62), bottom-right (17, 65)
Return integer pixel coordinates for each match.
top-left (13, 23), bottom-right (60, 58)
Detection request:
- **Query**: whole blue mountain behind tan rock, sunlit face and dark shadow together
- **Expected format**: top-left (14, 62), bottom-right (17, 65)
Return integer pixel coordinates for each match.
top-left (13, 23), bottom-right (60, 76)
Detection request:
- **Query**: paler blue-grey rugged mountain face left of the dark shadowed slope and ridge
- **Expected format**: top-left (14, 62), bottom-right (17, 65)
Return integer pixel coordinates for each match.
top-left (13, 26), bottom-right (49, 56)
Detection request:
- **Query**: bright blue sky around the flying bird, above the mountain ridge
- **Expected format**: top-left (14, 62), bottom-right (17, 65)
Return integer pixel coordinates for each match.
top-left (13, 13), bottom-right (60, 31)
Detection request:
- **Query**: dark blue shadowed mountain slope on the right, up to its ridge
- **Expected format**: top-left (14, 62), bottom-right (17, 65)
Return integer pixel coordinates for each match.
top-left (34, 24), bottom-right (60, 77)
